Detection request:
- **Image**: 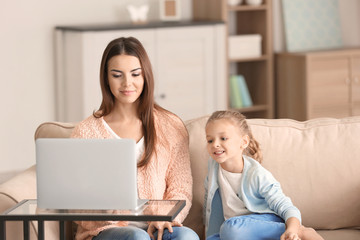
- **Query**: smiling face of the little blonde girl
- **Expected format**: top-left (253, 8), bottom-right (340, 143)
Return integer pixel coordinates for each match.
top-left (205, 119), bottom-right (249, 169)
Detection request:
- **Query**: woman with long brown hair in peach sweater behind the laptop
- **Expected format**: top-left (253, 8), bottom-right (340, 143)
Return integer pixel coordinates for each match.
top-left (72, 37), bottom-right (198, 240)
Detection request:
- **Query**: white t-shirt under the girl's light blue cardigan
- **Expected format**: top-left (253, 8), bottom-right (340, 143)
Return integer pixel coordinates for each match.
top-left (218, 166), bottom-right (251, 220)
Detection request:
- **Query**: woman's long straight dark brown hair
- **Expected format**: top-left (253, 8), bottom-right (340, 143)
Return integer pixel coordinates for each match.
top-left (94, 37), bottom-right (161, 167)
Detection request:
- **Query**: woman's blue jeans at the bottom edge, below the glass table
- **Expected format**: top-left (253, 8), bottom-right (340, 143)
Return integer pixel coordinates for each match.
top-left (92, 227), bottom-right (199, 240)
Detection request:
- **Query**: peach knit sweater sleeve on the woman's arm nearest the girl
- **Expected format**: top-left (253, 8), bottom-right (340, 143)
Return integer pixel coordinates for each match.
top-left (164, 122), bottom-right (193, 223)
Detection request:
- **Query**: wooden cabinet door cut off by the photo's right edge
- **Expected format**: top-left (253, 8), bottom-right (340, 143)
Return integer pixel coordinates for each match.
top-left (351, 55), bottom-right (360, 116)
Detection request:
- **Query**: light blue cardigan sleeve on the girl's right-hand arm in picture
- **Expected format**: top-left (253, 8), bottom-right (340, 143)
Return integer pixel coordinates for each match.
top-left (257, 169), bottom-right (301, 222)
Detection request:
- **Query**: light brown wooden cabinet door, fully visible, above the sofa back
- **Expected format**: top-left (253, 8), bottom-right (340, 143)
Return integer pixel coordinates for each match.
top-left (307, 56), bottom-right (350, 118)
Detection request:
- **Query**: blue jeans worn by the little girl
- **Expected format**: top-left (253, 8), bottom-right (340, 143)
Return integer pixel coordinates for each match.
top-left (206, 213), bottom-right (285, 240)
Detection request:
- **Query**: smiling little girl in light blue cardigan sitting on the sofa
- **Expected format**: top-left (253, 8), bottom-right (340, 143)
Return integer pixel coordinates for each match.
top-left (204, 111), bottom-right (323, 240)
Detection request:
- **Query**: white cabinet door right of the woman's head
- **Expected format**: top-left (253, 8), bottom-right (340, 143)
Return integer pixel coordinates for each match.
top-left (155, 26), bottom-right (218, 120)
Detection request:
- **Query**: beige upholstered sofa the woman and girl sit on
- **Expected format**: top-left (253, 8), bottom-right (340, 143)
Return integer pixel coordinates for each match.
top-left (0, 117), bottom-right (360, 240)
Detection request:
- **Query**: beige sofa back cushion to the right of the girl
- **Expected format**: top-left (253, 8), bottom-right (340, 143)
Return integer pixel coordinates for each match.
top-left (248, 117), bottom-right (360, 229)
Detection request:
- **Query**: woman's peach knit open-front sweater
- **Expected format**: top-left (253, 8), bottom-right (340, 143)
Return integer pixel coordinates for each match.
top-left (71, 110), bottom-right (192, 240)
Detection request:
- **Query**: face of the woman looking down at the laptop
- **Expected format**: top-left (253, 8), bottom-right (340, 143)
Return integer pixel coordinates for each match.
top-left (107, 55), bottom-right (144, 104)
